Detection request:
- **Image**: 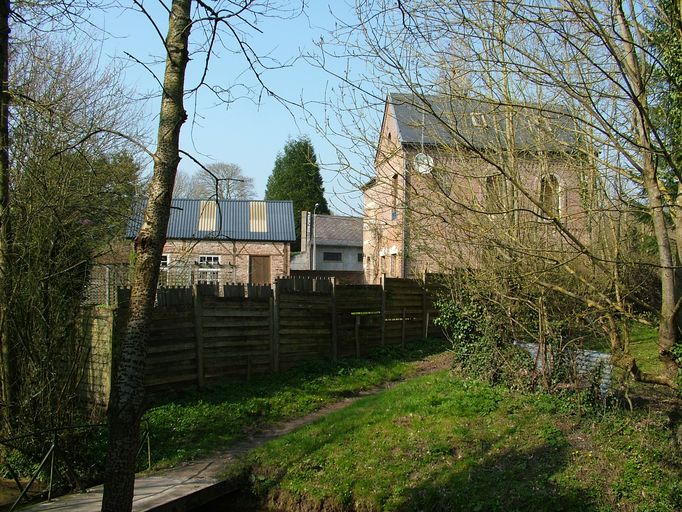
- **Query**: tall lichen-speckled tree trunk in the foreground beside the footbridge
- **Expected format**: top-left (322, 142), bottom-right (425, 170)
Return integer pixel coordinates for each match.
top-left (102, 0), bottom-right (192, 512)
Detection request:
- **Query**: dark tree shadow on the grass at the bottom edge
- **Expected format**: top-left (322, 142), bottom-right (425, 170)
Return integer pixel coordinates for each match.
top-left (400, 444), bottom-right (594, 512)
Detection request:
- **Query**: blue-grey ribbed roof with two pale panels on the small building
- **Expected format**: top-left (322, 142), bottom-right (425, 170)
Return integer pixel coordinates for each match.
top-left (127, 199), bottom-right (296, 242)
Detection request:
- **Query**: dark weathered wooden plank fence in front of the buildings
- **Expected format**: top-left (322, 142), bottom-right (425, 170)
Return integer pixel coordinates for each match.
top-left (107, 278), bottom-right (441, 392)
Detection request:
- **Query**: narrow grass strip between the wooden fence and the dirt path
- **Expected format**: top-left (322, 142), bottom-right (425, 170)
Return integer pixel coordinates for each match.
top-left (142, 340), bottom-right (448, 469)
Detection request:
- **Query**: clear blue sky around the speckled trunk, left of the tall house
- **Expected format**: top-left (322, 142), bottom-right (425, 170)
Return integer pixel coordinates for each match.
top-left (97, 0), bottom-right (380, 214)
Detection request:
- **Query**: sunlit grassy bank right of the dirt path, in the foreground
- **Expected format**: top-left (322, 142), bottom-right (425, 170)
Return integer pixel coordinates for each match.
top-left (245, 371), bottom-right (682, 512)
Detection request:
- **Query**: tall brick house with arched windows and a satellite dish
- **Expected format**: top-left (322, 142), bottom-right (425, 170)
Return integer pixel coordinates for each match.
top-left (363, 93), bottom-right (596, 283)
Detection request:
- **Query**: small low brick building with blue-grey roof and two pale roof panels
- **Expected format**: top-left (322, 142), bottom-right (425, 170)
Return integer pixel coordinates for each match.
top-left (128, 199), bottom-right (296, 286)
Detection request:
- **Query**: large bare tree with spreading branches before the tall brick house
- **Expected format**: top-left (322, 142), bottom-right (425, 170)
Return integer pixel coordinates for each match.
top-left (323, 0), bottom-right (682, 387)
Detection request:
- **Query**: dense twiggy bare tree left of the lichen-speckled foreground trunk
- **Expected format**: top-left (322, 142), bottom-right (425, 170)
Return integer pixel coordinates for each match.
top-left (6, 36), bottom-right (139, 434)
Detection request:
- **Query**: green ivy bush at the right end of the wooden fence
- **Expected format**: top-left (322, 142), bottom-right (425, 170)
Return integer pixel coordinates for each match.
top-left (434, 299), bottom-right (532, 388)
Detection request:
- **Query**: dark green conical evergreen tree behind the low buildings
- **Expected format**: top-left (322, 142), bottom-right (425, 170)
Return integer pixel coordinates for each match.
top-left (265, 137), bottom-right (329, 250)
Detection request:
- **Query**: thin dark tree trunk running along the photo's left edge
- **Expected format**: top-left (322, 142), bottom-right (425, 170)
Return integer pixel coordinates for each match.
top-left (0, 0), bottom-right (17, 434)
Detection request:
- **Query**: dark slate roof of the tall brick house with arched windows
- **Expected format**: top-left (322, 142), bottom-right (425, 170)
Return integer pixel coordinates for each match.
top-left (388, 93), bottom-right (577, 151)
